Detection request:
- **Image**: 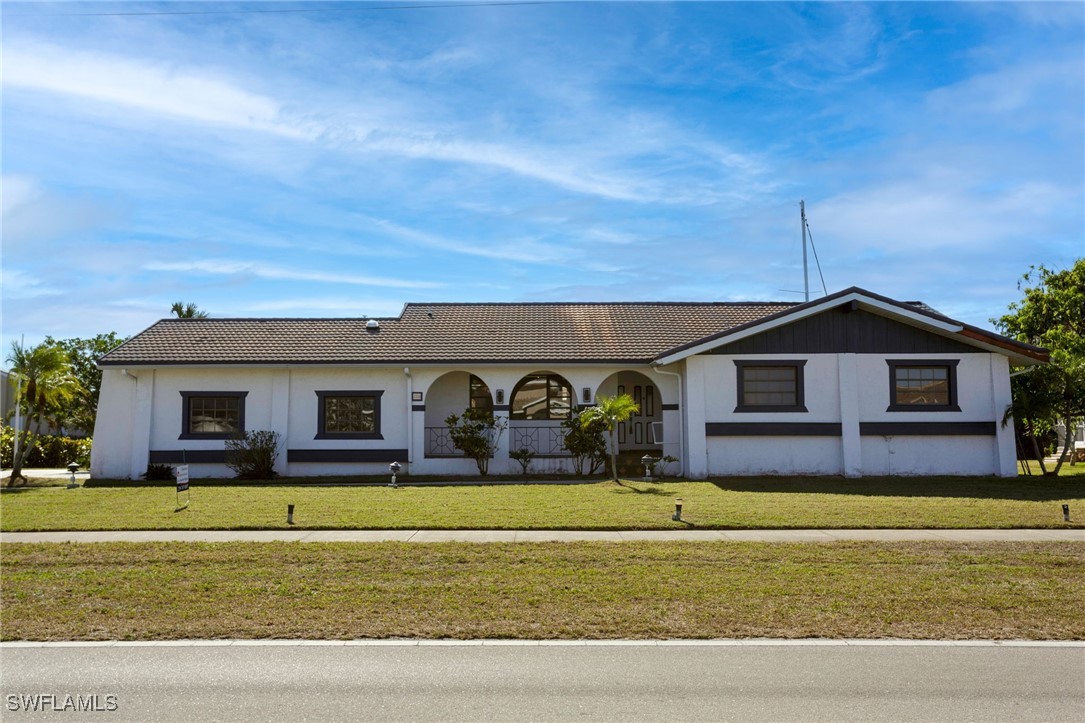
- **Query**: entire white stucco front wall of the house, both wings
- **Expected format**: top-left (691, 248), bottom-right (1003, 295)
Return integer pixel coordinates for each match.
top-left (91, 353), bottom-right (1017, 479)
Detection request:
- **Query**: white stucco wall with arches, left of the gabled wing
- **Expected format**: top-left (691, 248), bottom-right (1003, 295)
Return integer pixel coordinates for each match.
top-left (91, 365), bottom-right (680, 479)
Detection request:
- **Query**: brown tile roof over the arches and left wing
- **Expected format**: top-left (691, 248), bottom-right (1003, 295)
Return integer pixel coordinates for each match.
top-left (101, 302), bottom-right (795, 366)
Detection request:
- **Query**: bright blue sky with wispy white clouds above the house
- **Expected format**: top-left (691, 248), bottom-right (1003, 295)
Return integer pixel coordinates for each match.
top-left (2, 2), bottom-right (1085, 356)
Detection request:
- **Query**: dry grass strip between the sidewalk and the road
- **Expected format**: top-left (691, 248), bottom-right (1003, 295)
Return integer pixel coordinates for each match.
top-left (0, 543), bottom-right (1085, 640)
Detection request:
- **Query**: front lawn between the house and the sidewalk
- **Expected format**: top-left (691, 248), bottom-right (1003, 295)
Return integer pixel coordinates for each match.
top-left (0, 477), bottom-right (1085, 532)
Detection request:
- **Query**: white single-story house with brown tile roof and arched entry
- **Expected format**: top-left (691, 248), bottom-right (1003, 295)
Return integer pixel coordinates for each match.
top-left (91, 288), bottom-right (1047, 479)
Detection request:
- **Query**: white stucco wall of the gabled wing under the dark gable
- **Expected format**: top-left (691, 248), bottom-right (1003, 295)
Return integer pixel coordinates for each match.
top-left (686, 353), bottom-right (1017, 478)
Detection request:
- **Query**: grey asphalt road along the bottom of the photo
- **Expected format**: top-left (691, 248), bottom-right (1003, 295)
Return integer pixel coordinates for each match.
top-left (0, 644), bottom-right (1085, 721)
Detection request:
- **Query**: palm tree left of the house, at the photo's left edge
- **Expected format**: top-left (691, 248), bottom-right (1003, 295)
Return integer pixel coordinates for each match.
top-left (8, 342), bottom-right (81, 485)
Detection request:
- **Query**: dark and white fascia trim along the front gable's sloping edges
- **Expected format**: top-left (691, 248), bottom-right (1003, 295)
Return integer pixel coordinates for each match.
top-left (652, 287), bottom-right (1049, 365)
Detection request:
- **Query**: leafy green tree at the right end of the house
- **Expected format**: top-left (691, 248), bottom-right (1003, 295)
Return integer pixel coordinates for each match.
top-left (992, 258), bottom-right (1085, 475)
